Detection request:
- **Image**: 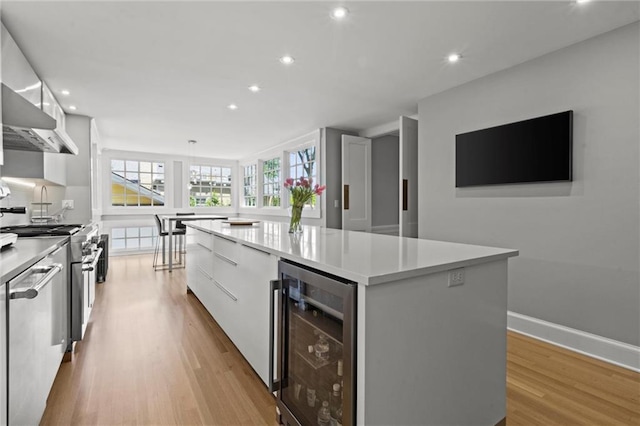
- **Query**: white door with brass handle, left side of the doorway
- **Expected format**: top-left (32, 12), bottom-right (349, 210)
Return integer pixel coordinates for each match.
top-left (342, 135), bottom-right (371, 232)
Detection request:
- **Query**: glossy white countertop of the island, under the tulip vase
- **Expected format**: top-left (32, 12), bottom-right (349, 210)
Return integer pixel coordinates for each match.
top-left (185, 220), bottom-right (518, 285)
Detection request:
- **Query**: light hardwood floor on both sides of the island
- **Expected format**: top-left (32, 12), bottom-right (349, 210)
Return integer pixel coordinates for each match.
top-left (42, 255), bottom-right (640, 426)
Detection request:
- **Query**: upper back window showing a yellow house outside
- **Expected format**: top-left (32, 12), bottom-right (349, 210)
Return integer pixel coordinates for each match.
top-left (111, 160), bottom-right (165, 207)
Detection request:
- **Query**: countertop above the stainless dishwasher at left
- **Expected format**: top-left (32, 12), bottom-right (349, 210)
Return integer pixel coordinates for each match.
top-left (0, 237), bottom-right (69, 284)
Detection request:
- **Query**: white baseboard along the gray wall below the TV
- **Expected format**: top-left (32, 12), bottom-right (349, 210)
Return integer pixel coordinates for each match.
top-left (507, 311), bottom-right (640, 372)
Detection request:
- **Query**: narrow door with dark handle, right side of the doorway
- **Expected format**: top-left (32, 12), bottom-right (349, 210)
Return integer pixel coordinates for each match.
top-left (399, 116), bottom-right (418, 238)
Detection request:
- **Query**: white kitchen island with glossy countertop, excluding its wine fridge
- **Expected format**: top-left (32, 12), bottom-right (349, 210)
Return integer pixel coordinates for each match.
top-left (187, 221), bottom-right (518, 425)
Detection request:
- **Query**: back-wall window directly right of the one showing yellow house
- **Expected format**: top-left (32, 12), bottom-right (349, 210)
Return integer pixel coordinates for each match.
top-left (189, 165), bottom-right (231, 207)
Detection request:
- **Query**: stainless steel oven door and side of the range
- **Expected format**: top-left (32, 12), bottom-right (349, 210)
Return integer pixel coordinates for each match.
top-left (71, 248), bottom-right (102, 342)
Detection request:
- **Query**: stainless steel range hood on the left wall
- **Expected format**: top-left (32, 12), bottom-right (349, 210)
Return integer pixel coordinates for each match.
top-left (2, 84), bottom-right (78, 155)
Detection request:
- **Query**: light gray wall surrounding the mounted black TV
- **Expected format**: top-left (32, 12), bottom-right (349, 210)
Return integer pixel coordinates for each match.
top-left (418, 23), bottom-right (640, 345)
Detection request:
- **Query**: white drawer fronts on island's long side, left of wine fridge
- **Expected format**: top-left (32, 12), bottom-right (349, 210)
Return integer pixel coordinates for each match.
top-left (187, 226), bottom-right (278, 384)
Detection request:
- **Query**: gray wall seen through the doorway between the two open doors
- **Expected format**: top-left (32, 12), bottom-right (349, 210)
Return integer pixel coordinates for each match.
top-left (371, 135), bottom-right (400, 227)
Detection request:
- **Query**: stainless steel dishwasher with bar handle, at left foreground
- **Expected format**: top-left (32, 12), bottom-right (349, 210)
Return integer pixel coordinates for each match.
top-left (7, 244), bottom-right (69, 425)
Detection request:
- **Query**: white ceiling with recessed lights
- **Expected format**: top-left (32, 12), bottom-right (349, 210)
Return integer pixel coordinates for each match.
top-left (2, 0), bottom-right (639, 159)
